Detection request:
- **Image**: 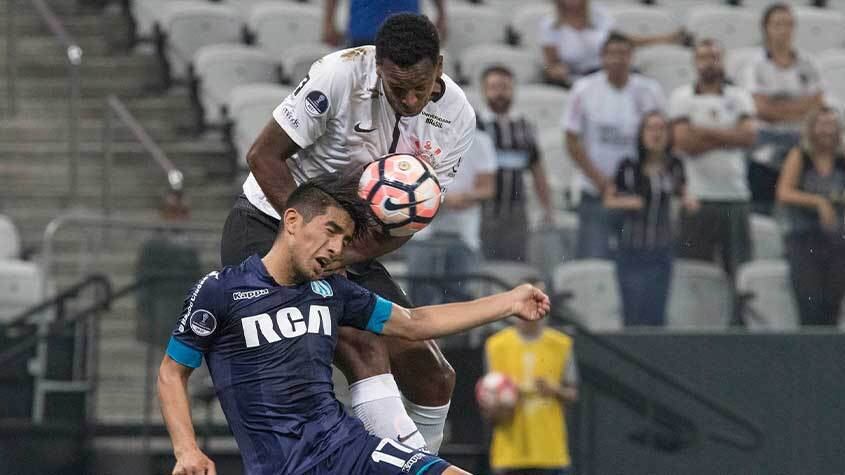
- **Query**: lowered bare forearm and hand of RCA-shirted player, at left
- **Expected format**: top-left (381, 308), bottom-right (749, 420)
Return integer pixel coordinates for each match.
top-left (158, 355), bottom-right (217, 475)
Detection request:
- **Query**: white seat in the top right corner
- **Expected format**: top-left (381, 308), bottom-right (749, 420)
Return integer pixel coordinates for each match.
top-left (794, 7), bottom-right (845, 54)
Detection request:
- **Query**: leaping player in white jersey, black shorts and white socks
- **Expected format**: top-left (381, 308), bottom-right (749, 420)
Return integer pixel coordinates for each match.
top-left (221, 14), bottom-right (475, 452)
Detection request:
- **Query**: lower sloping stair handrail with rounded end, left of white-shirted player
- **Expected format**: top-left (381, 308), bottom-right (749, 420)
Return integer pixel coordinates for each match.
top-left (100, 94), bottom-right (184, 217)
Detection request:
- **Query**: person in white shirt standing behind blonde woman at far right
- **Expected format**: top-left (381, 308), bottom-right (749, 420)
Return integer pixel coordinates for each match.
top-left (743, 3), bottom-right (824, 213)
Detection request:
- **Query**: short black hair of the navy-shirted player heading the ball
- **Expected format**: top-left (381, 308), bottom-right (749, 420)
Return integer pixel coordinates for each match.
top-left (286, 173), bottom-right (372, 242)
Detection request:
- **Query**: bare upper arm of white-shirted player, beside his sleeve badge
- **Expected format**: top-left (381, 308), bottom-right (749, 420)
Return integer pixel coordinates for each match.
top-left (246, 119), bottom-right (299, 215)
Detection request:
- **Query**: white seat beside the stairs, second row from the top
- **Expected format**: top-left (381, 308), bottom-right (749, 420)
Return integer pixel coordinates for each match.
top-left (193, 44), bottom-right (281, 125)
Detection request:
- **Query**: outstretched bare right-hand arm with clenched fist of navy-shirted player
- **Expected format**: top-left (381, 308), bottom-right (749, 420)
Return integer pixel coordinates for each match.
top-left (382, 284), bottom-right (550, 340)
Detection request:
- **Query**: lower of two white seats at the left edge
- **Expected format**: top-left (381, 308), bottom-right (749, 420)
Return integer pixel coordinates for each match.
top-left (0, 260), bottom-right (44, 322)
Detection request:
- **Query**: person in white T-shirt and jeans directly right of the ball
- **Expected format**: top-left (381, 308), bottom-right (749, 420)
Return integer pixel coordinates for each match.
top-left (408, 130), bottom-right (496, 305)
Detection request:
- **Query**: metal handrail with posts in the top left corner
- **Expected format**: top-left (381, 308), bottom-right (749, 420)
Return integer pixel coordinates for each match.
top-left (6, 0), bottom-right (82, 203)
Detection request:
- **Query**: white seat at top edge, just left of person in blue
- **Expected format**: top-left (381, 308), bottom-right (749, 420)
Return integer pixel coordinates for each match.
top-left (247, 2), bottom-right (323, 60)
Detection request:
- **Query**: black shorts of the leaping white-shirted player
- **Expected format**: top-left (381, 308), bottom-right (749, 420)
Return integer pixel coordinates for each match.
top-left (220, 195), bottom-right (413, 308)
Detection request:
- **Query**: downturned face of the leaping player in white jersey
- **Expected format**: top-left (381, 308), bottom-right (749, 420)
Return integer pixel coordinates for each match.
top-left (376, 56), bottom-right (443, 117)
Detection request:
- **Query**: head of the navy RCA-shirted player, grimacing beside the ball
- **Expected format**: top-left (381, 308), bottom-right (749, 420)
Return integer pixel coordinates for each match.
top-left (277, 175), bottom-right (370, 281)
